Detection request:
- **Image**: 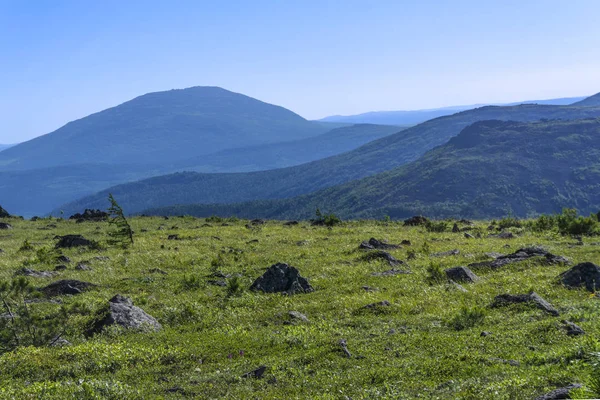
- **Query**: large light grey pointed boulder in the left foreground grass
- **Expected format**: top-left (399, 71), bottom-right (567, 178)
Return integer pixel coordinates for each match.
top-left (88, 294), bottom-right (162, 334)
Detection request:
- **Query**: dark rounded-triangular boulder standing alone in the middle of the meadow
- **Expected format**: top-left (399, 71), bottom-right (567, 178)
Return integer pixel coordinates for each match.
top-left (250, 263), bottom-right (314, 294)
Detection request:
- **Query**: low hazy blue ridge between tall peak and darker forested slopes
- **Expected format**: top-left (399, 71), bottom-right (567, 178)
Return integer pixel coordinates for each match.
top-left (174, 124), bottom-right (403, 172)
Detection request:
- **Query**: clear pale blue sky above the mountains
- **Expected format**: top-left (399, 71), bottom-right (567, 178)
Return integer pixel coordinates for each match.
top-left (0, 0), bottom-right (600, 143)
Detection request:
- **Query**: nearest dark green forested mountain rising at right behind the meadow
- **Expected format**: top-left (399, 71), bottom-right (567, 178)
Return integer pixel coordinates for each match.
top-left (145, 118), bottom-right (600, 218)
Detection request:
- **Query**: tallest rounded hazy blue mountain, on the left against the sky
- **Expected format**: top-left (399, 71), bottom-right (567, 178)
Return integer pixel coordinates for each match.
top-left (0, 87), bottom-right (331, 171)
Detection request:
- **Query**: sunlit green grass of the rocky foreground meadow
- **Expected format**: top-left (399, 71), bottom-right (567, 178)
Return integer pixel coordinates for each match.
top-left (0, 218), bottom-right (600, 399)
